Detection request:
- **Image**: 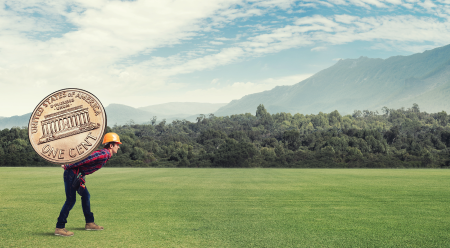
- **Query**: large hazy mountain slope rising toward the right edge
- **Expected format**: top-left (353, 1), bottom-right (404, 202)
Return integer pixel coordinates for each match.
top-left (215, 45), bottom-right (450, 116)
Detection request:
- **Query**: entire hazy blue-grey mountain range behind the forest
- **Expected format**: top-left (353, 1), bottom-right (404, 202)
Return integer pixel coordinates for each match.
top-left (0, 45), bottom-right (450, 129)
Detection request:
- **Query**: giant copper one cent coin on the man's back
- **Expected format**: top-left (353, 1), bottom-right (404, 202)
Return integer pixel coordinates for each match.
top-left (28, 88), bottom-right (106, 164)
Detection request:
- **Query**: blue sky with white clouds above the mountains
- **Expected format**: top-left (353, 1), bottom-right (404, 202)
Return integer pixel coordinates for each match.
top-left (0, 0), bottom-right (450, 117)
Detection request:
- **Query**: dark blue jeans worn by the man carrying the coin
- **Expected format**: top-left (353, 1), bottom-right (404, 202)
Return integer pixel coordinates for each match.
top-left (56, 170), bottom-right (94, 228)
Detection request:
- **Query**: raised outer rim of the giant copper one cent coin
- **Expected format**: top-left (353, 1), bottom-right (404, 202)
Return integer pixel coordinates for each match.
top-left (28, 88), bottom-right (108, 164)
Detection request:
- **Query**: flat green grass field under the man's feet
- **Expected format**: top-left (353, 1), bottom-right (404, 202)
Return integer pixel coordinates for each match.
top-left (0, 167), bottom-right (450, 247)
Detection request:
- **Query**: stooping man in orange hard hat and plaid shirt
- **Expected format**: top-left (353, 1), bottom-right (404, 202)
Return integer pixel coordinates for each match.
top-left (55, 133), bottom-right (122, 236)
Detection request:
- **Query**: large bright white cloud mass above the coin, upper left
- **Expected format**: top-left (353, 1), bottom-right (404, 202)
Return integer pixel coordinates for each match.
top-left (0, 1), bottom-right (251, 116)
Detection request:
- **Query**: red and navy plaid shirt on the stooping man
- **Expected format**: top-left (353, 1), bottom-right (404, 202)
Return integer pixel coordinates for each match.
top-left (64, 149), bottom-right (111, 175)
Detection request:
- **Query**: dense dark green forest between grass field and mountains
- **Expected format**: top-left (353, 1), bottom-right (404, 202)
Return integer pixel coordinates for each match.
top-left (0, 104), bottom-right (450, 168)
